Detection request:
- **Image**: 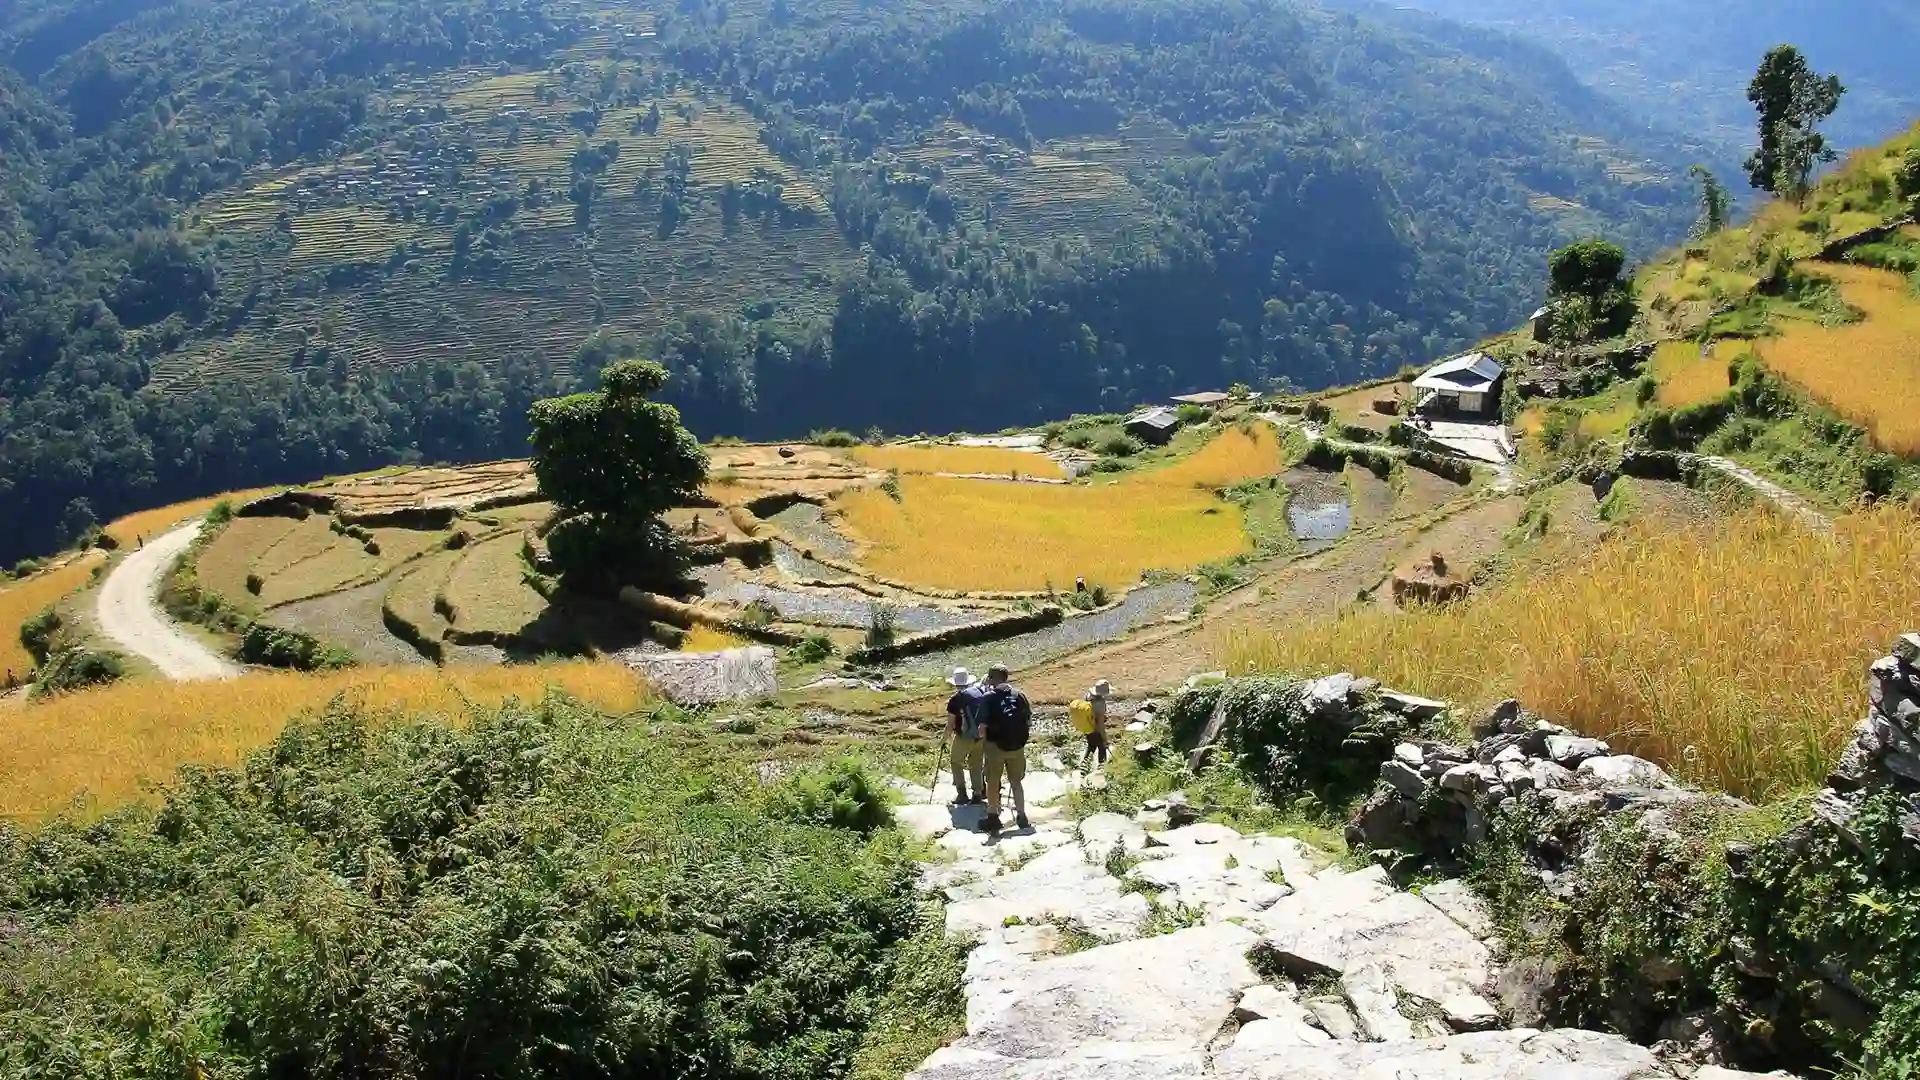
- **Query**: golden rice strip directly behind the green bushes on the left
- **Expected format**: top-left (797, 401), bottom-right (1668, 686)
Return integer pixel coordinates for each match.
top-left (0, 661), bottom-right (649, 821)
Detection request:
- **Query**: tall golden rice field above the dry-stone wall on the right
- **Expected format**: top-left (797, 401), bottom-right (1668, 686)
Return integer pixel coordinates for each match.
top-left (1215, 507), bottom-right (1920, 799)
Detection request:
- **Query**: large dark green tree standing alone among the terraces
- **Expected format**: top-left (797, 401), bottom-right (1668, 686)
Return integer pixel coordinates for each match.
top-left (528, 359), bottom-right (707, 584)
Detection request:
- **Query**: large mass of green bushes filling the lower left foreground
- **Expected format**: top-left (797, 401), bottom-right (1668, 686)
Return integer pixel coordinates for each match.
top-left (0, 698), bottom-right (929, 1080)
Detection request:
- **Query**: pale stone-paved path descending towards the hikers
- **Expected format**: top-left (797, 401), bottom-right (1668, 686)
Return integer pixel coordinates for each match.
top-left (895, 755), bottom-right (1789, 1080)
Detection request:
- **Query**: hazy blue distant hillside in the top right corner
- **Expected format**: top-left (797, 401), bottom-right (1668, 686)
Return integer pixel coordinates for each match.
top-left (1390, 0), bottom-right (1920, 148)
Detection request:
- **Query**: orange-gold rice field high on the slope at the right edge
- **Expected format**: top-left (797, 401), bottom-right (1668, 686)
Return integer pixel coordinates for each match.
top-left (1759, 265), bottom-right (1920, 457)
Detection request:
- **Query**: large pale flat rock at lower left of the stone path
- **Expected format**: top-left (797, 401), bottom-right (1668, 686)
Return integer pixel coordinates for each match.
top-left (960, 922), bottom-right (1261, 1059)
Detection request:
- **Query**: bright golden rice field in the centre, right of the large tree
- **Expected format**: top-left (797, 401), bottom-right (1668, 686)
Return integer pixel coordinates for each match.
top-left (837, 477), bottom-right (1250, 590)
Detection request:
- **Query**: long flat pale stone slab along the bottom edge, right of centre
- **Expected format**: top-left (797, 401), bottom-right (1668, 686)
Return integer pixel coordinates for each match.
top-left (1213, 1028), bottom-right (1672, 1080)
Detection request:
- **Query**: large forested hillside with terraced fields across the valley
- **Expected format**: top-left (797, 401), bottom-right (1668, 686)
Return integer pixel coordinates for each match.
top-left (0, 0), bottom-right (1692, 557)
